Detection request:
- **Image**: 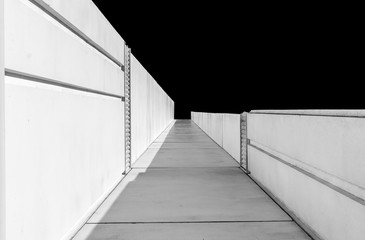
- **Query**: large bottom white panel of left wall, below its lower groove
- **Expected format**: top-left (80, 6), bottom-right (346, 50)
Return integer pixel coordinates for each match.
top-left (5, 77), bottom-right (124, 239)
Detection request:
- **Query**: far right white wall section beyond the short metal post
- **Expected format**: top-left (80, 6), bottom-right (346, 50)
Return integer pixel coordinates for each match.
top-left (191, 112), bottom-right (240, 162)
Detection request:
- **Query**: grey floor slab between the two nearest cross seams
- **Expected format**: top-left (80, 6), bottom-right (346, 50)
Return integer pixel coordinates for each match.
top-left (86, 168), bottom-right (290, 223)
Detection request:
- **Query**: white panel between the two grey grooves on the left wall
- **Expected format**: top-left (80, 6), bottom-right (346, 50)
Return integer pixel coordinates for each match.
top-left (5, 0), bottom-right (124, 96)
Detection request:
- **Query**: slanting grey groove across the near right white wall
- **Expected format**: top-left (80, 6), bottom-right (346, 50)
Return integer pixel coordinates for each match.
top-left (248, 143), bottom-right (365, 206)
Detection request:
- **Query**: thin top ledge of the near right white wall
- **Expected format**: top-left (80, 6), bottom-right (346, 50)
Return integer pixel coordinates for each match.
top-left (250, 109), bottom-right (365, 117)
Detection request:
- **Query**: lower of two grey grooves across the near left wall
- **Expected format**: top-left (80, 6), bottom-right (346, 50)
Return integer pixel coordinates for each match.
top-left (5, 68), bottom-right (124, 101)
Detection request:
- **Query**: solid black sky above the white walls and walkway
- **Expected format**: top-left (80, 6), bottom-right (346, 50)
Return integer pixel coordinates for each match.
top-left (94, 0), bottom-right (365, 119)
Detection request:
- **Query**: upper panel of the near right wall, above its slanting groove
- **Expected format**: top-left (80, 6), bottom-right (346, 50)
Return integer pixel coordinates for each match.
top-left (248, 114), bottom-right (365, 199)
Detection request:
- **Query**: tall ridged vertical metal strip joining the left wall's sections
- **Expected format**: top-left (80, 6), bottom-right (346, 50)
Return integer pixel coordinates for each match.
top-left (124, 45), bottom-right (132, 174)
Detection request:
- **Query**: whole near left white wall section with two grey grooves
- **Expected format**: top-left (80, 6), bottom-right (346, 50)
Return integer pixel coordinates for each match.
top-left (0, 0), bottom-right (124, 240)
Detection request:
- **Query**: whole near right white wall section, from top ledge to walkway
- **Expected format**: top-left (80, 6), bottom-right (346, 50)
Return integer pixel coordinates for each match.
top-left (248, 111), bottom-right (365, 240)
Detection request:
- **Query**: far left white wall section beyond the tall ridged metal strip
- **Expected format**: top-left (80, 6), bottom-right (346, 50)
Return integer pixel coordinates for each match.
top-left (131, 55), bottom-right (174, 162)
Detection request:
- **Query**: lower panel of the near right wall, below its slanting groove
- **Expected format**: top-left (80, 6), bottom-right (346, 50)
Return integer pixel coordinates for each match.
top-left (249, 147), bottom-right (365, 240)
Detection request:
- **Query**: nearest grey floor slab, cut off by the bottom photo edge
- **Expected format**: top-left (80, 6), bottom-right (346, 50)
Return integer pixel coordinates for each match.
top-left (78, 222), bottom-right (308, 240)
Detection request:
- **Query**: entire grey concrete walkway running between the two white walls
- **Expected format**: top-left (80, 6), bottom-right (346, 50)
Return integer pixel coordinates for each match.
top-left (75, 120), bottom-right (310, 240)
